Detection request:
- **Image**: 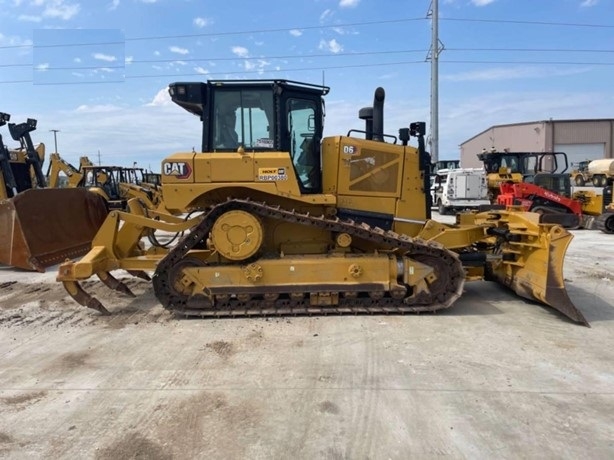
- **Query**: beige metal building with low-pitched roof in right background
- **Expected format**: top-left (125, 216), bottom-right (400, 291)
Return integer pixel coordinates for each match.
top-left (460, 118), bottom-right (614, 168)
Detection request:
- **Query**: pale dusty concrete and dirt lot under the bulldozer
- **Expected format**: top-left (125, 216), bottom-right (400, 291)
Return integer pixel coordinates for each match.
top-left (0, 220), bottom-right (614, 459)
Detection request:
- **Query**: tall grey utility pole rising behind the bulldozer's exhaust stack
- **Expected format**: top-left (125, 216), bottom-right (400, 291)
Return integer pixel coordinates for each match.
top-left (426, 0), bottom-right (444, 163)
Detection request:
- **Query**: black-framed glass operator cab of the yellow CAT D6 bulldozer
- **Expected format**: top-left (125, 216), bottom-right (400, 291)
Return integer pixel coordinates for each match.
top-left (169, 80), bottom-right (329, 194)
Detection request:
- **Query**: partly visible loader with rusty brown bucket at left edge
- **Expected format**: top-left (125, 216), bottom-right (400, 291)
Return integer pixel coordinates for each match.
top-left (0, 113), bottom-right (107, 272)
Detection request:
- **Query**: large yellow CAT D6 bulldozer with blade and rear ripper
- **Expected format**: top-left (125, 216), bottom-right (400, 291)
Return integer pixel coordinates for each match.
top-left (57, 80), bottom-right (588, 324)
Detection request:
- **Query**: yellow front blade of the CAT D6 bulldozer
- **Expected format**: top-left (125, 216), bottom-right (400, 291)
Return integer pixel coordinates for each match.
top-left (489, 221), bottom-right (590, 327)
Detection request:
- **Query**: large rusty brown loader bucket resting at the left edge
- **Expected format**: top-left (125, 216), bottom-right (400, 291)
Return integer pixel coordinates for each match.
top-left (0, 188), bottom-right (108, 272)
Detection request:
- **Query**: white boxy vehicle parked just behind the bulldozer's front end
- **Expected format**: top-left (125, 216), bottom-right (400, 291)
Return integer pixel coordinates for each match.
top-left (431, 168), bottom-right (490, 215)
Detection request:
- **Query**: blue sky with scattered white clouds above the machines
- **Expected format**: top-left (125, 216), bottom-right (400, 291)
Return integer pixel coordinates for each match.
top-left (0, 0), bottom-right (614, 172)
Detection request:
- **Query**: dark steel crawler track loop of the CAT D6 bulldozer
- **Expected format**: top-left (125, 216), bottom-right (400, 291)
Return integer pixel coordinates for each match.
top-left (152, 199), bottom-right (465, 317)
